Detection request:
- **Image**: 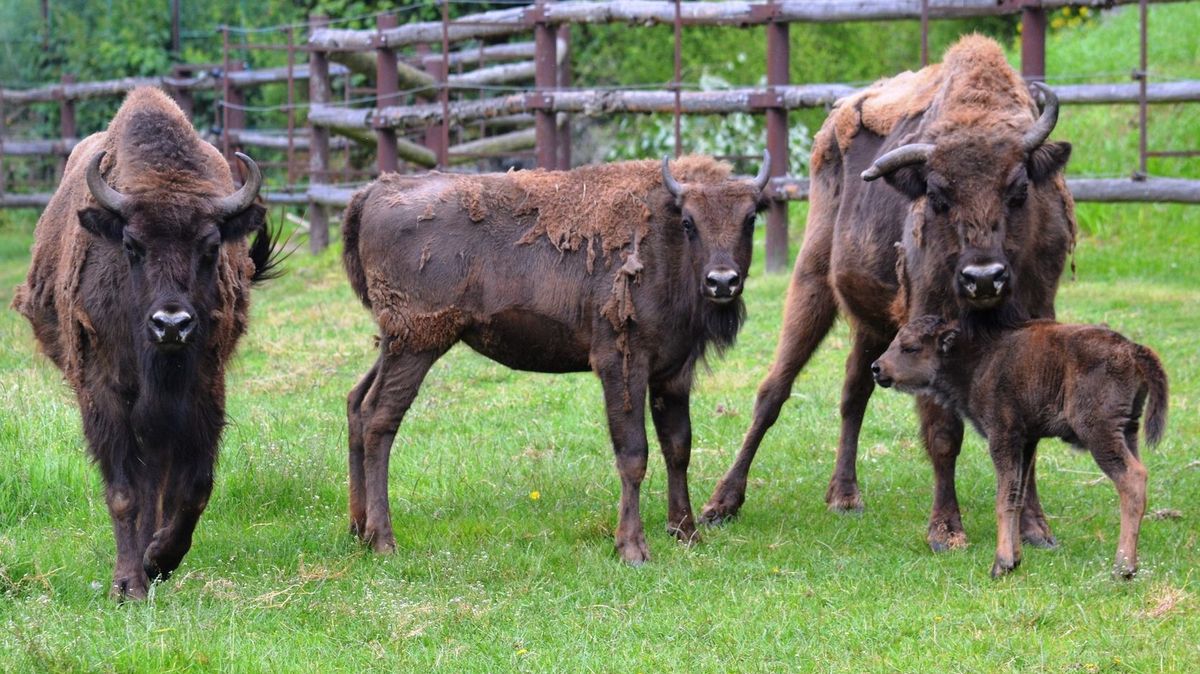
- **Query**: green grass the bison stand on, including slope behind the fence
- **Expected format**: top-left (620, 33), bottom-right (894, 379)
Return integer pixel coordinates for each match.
top-left (0, 7), bottom-right (1200, 672)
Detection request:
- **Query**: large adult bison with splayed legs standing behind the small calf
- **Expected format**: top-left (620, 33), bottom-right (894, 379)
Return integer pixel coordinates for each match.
top-left (701, 36), bottom-right (1075, 549)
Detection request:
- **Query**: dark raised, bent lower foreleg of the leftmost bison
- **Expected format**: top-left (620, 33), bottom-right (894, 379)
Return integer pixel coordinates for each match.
top-left (142, 458), bottom-right (212, 580)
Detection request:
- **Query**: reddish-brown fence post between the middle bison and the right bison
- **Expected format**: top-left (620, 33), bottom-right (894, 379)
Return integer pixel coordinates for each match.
top-left (767, 2), bottom-right (790, 273)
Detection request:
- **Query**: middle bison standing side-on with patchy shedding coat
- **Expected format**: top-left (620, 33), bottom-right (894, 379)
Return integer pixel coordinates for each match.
top-left (342, 157), bottom-right (767, 564)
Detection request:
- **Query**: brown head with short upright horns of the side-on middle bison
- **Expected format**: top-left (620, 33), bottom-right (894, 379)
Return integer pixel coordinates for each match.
top-left (662, 152), bottom-right (770, 306)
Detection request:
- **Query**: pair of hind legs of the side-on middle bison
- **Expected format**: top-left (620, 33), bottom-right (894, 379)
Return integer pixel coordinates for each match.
top-left (361, 344), bottom-right (445, 554)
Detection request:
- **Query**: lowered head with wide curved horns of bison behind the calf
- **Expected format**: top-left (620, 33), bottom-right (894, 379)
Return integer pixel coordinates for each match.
top-left (863, 83), bottom-right (1070, 311)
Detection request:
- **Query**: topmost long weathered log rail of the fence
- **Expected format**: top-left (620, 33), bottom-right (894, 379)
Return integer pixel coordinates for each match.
top-left (308, 0), bottom-right (1180, 52)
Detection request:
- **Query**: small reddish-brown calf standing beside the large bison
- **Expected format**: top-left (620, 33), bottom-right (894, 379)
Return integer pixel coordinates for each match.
top-left (871, 315), bottom-right (1166, 578)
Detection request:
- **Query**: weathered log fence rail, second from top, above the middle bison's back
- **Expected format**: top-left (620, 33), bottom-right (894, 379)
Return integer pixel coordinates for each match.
top-left (308, 84), bottom-right (856, 128)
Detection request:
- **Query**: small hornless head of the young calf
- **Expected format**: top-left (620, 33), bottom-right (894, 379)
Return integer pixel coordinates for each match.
top-left (871, 315), bottom-right (959, 393)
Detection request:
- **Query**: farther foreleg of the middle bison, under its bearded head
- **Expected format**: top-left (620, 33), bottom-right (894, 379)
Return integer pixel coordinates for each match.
top-left (650, 371), bottom-right (700, 544)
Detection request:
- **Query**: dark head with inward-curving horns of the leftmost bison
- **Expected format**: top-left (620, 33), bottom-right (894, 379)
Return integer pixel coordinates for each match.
top-left (79, 151), bottom-right (266, 351)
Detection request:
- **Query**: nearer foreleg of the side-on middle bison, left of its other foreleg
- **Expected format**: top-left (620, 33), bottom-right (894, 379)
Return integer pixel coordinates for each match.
top-left (593, 353), bottom-right (650, 566)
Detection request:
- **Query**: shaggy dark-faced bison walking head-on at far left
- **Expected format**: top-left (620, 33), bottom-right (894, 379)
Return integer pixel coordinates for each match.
top-left (13, 88), bottom-right (271, 598)
